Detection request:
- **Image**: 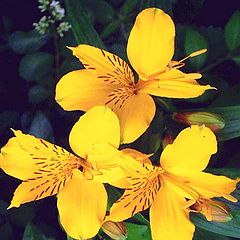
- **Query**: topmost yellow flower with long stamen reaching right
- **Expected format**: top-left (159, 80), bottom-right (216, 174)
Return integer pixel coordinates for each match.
top-left (56, 8), bottom-right (213, 143)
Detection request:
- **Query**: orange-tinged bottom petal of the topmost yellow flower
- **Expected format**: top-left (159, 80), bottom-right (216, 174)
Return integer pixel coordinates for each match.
top-left (108, 94), bottom-right (156, 143)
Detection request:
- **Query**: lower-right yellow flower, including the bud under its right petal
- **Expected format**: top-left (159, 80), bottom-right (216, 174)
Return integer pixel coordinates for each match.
top-left (106, 126), bottom-right (239, 240)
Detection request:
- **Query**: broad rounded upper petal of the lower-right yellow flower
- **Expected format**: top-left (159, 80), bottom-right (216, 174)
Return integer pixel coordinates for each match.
top-left (160, 125), bottom-right (217, 175)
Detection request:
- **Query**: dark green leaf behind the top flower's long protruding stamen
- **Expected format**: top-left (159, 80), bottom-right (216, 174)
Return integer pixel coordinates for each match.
top-left (184, 27), bottom-right (208, 70)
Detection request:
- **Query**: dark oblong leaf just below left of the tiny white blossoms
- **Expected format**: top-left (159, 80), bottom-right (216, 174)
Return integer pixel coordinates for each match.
top-left (8, 31), bottom-right (48, 54)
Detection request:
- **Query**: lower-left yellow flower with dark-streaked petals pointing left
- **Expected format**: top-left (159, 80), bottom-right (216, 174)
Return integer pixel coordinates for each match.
top-left (0, 106), bottom-right (130, 239)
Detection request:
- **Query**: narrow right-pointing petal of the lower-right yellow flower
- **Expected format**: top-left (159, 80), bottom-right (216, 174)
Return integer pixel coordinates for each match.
top-left (179, 172), bottom-right (240, 202)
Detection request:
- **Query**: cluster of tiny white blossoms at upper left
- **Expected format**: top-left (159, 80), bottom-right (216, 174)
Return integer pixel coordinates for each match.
top-left (33, 0), bottom-right (71, 37)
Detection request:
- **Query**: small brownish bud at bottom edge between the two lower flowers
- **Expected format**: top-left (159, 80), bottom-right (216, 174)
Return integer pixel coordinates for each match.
top-left (102, 221), bottom-right (127, 240)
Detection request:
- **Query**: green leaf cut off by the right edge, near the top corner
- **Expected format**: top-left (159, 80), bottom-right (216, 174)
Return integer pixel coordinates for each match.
top-left (224, 11), bottom-right (240, 51)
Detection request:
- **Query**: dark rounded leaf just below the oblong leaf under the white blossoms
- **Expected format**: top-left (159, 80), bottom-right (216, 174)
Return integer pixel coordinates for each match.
top-left (19, 52), bottom-right (53, 81)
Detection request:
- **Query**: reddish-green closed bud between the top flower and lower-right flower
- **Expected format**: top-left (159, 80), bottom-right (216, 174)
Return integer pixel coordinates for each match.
top-left (172, 112), bottom-right (225, 132)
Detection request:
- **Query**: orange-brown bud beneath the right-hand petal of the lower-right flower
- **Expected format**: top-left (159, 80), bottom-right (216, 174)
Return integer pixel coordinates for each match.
top-left (190, 200), bottom-right (232, 222)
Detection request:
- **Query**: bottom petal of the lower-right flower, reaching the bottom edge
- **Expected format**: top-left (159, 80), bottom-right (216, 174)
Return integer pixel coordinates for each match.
top-left (150, 185), bottom-right (195, 240)
